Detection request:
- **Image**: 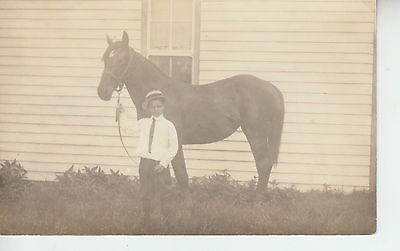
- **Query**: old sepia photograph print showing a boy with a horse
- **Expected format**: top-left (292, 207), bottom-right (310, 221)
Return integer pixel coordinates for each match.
top-left (0, 0), bottom-right (379, 235)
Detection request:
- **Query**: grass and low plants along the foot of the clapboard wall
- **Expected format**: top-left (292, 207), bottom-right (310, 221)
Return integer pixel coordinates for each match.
top-left (0, 168), bottom-right (376, 235)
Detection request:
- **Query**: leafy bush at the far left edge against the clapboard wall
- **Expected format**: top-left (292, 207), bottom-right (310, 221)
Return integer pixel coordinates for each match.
top-left (0, 159), bottom-right (26, 200)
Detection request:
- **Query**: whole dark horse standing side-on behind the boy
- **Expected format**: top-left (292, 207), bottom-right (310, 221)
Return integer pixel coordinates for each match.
top-left (97, 32), bottom-right (284, 189)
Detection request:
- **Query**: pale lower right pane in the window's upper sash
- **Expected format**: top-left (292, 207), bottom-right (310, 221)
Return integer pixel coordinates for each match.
top-left (172, 22), bottom-right (192, 50)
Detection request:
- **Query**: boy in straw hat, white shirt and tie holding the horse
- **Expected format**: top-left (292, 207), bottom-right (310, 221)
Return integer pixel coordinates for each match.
top-left (119, 90), bottom-right (178, 225)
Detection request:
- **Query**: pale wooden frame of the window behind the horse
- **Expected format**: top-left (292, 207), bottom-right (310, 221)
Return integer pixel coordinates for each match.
top-left (141, 0), bottom-right (201, 84)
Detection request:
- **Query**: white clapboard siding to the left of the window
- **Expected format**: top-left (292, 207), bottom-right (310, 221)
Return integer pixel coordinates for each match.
top-left (0, 0), bottom-right (143, 180)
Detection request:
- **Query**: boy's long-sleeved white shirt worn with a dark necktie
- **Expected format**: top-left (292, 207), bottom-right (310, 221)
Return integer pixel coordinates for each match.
top-left (120, 113), bottom-right (178, 167)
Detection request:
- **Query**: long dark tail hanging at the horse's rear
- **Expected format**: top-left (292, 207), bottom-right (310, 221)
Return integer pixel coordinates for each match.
top-left (268, 88), bottom-right (285, 164)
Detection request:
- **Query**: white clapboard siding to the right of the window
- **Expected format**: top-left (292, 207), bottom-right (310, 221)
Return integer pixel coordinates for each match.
top-left (200, 0), bottom-right (375, 190)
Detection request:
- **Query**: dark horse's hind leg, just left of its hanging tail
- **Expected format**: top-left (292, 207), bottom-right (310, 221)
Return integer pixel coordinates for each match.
top-left (242, 126), bottom-right (273, 191)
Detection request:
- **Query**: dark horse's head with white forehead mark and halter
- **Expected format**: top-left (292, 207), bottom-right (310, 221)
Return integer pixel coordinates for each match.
top-left (97, 31), bottom-right (133, 101)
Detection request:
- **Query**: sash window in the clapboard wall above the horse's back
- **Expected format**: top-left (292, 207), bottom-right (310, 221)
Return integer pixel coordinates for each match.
top-left (146, 0), bottom-right (196, 84)
